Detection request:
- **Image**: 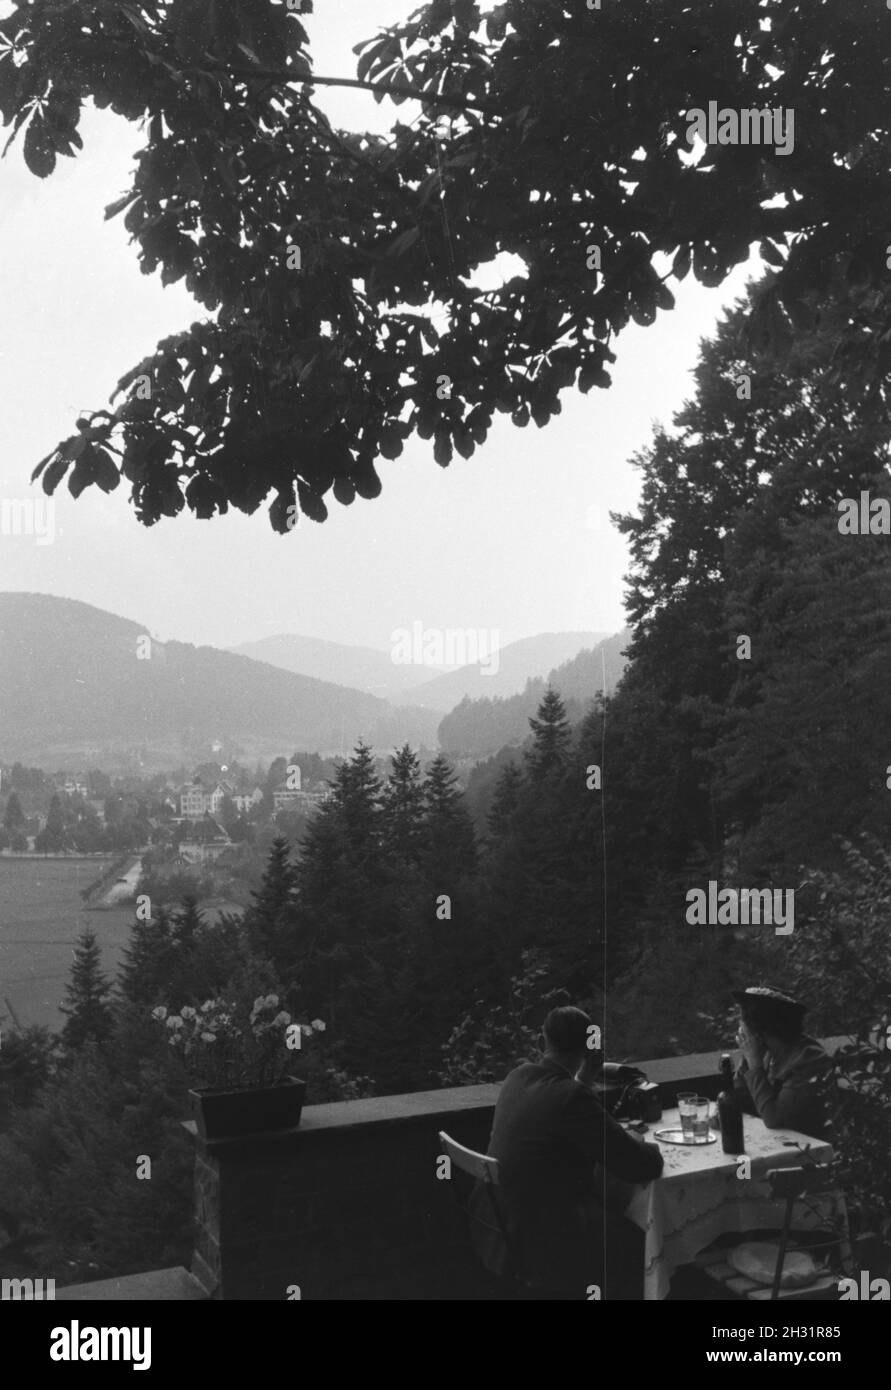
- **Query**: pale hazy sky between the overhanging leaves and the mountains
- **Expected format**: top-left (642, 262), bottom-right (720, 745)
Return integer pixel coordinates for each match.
top-left (0, 0), bottom-right (756, 648)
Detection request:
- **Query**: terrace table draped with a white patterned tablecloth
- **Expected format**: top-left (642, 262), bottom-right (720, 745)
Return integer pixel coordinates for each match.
top-left (626, 1109), bottom-right (845, 1301)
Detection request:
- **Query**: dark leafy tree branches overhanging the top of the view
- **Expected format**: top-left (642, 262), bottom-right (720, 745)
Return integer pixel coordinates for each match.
top-left (0, 0), bottom-right (891, 531)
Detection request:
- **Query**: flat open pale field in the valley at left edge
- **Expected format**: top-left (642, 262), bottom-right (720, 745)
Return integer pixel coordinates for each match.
top-left (0, 855), bottom-right (133, 1029)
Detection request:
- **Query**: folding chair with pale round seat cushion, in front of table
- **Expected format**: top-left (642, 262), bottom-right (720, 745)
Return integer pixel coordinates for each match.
top-left (696, 1163), bottom-right (845, 1302)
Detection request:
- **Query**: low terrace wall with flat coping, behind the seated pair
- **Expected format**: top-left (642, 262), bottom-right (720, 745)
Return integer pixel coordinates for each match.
top-left (186, 1040), bottom-right (837, 1300)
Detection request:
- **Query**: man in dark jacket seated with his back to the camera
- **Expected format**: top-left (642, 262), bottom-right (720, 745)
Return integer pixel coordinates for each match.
top-left (471, 1006), bottom-right (662, 1300)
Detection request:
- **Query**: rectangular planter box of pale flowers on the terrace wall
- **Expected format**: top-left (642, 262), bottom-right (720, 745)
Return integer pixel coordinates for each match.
top-left (152, 994), bottom-right (325, 1091)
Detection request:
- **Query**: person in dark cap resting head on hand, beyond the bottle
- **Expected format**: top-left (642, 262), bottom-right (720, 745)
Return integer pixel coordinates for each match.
top-left (734, 986), bottom-right (831, 1138)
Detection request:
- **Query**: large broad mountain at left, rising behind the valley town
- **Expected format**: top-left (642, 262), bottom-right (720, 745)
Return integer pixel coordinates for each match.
top-left (0, 592), bottom-right (435, 766)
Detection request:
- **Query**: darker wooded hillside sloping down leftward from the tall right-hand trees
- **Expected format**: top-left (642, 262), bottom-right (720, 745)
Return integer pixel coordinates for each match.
top-left (439, 630), bottom-right (631, 758)
